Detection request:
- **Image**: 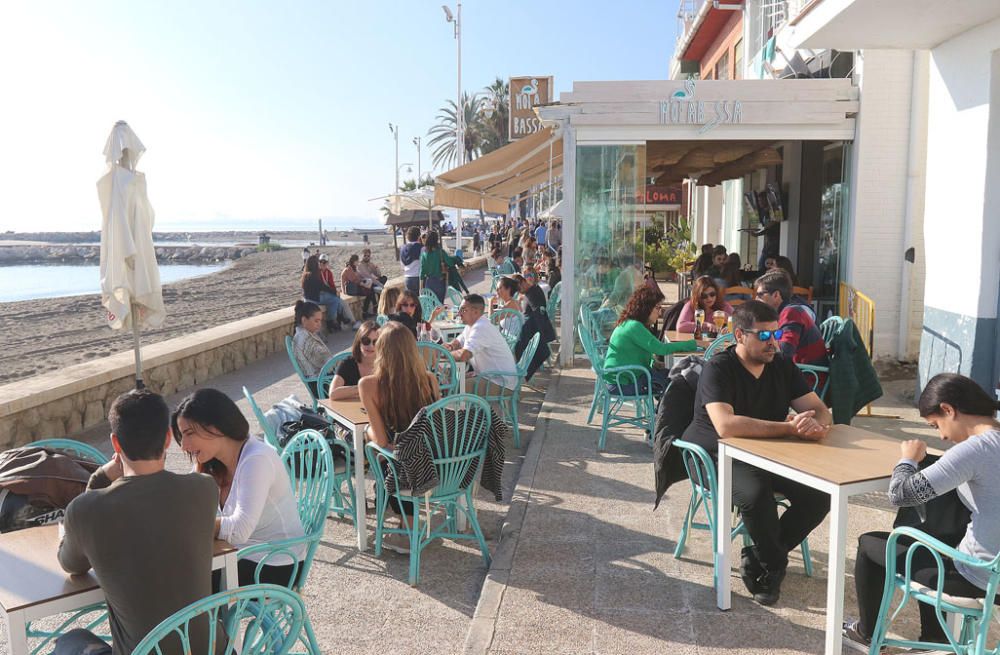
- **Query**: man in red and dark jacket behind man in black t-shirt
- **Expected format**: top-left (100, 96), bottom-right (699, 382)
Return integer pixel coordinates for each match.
top-left (754, 268), bottom-right (828, 366)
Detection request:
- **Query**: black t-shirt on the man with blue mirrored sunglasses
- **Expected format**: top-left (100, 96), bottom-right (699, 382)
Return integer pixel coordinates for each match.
top-left (683, 346), bottom-right (812, 453)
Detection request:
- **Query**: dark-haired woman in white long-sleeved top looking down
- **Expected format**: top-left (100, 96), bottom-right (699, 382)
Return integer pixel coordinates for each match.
top-left (171, 389), bottom-right (305, 588)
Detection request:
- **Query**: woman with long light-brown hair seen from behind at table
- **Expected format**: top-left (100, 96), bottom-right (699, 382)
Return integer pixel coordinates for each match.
top-left (358, 321), bottom-right (441, 551)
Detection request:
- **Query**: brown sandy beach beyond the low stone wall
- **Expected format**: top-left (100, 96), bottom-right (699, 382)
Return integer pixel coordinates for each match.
top-left (0, 233), bottom-right (401, 384)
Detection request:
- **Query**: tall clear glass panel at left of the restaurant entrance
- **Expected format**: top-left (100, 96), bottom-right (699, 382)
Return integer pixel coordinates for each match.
top-left (574, 145), bottom-right (646, 326)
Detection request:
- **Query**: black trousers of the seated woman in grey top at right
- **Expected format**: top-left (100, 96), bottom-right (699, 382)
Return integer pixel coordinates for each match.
top-left (854, 532), bottom-right (1000, 643)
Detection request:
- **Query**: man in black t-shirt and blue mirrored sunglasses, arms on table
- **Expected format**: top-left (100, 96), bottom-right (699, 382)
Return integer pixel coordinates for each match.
top-left (683, 300), bottom-right (833, 605)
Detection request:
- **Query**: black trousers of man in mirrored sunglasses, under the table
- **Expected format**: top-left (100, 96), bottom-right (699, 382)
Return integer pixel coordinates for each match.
top-left (732, 461), bottom-right (830, 571)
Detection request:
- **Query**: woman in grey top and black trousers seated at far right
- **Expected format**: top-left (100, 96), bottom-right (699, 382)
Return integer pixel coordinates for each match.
top-left (844, 373), bottom-right (1000, 646)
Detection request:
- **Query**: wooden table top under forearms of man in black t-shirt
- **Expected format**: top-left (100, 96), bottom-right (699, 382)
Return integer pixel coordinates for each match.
top-left (722, 425), bottom-right (900, 485)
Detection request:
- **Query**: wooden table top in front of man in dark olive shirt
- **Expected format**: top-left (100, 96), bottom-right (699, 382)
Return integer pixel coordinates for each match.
top-left (0, 524), bottom-right (236, 612)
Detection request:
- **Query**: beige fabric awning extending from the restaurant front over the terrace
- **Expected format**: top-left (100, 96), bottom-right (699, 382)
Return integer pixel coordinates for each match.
top-left (434, 128), bottom-right (563, 214)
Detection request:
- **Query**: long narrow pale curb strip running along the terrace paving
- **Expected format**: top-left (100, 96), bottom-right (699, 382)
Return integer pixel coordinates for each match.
top-left (462, 369), bottom-right (562, 655)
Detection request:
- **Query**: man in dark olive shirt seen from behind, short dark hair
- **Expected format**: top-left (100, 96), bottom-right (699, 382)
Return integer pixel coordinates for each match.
top-left (53, 389), bottom-right (219, 655)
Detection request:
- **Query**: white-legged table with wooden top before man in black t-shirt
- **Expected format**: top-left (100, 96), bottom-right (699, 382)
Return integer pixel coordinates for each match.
top-left (715, 425), bottom-right (900, 655)
